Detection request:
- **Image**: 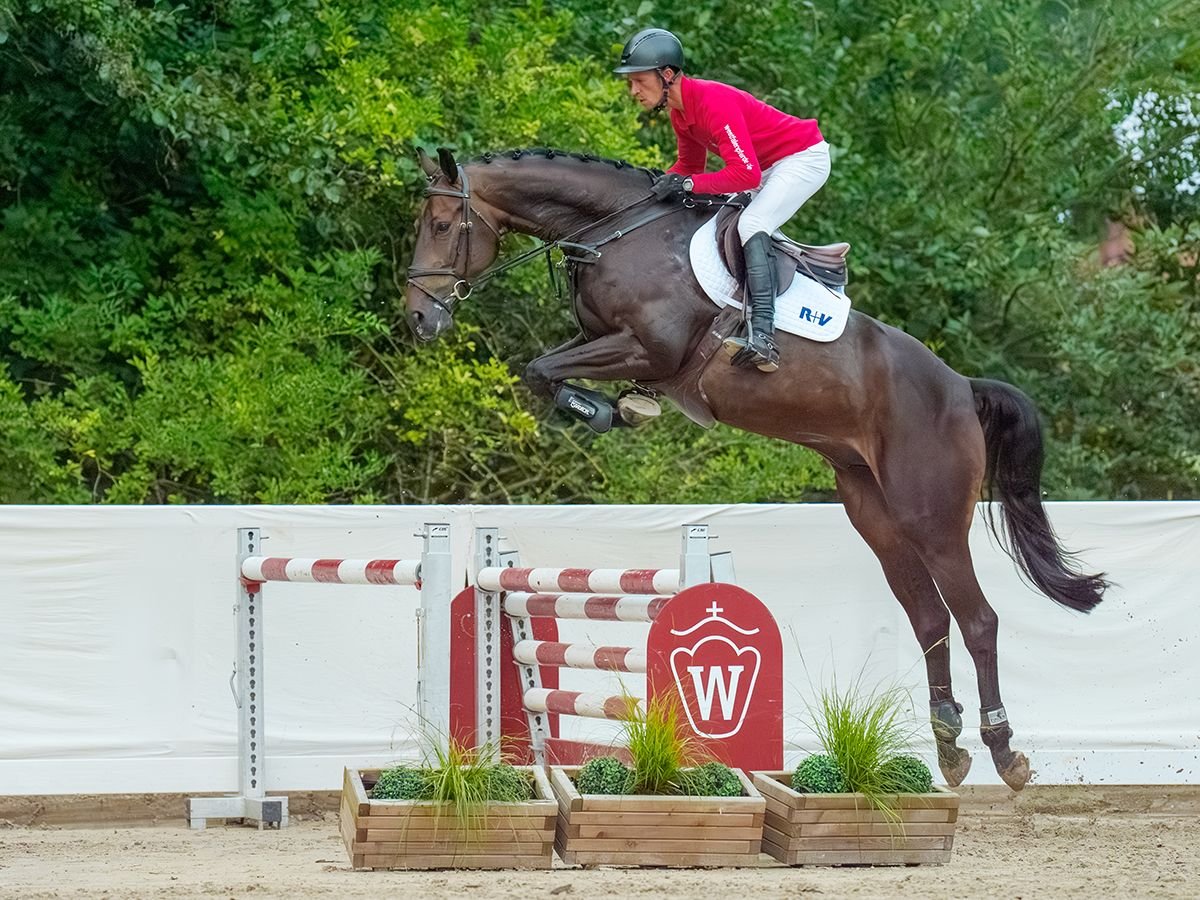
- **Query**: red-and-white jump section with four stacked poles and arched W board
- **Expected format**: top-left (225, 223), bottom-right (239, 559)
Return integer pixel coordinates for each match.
top-left (450, 524), bottom-right (782, 769)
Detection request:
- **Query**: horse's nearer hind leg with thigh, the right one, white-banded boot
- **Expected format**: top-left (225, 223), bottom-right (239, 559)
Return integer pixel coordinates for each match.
top-left (880, 420), bottom-right (1030, 791)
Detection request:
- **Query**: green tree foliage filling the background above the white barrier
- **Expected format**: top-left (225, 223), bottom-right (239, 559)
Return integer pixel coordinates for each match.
top-left (0, 0), bottom-right (1200, 503)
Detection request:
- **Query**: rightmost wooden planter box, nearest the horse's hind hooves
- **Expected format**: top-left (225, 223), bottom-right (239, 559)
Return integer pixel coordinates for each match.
top-left (752, 772), bottom-right (959, 865)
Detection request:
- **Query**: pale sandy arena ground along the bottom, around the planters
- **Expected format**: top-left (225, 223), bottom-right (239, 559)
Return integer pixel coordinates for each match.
top-left (0, 786), bottom-right (1200, 900)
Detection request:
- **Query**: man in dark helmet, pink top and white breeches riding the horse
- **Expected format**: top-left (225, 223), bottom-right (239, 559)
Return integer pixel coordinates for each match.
top-left (613, 28), bottom-right (829, 372)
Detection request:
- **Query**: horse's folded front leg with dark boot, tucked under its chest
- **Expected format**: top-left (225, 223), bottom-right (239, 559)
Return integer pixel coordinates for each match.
top-left (523, 331), bottom-right (678, 434)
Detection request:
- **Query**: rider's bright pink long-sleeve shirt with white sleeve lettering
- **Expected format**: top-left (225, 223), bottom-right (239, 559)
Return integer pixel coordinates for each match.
top-left (667, 77), bottom-right (824, 193)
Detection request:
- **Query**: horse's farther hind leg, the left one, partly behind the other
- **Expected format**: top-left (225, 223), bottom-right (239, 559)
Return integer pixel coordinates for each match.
top-left (836, 467), bottom-right (971, 787)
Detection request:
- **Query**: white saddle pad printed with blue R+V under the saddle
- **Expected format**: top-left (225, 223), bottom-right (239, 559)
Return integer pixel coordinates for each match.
top-left (689, 216), bottom-right (850, 341)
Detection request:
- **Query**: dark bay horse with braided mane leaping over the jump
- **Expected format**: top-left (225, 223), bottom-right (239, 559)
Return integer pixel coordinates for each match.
top-left (406, 150), bottom-right (1106, 790)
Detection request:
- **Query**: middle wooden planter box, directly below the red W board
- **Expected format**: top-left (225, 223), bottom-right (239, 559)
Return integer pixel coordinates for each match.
top-left (550, 766), bottom-right (767, 866)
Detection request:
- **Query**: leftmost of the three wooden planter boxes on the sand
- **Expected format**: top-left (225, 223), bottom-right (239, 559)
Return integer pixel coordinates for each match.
top-left (340, 767), bottom-right (558, 869)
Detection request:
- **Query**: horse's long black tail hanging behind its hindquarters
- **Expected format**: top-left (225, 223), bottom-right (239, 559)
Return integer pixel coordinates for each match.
top-left (971, 378), bottom-right (1109, 612)
